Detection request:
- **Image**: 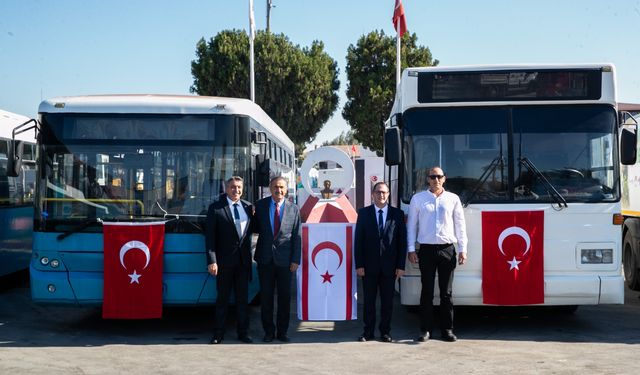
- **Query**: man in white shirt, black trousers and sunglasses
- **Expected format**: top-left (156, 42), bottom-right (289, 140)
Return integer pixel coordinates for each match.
top-left (407, 167), bottom-right (467, 342)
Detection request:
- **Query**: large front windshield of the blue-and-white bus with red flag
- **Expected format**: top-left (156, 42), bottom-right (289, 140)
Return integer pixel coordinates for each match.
top-left (36, 114), bottom-right (251, 232)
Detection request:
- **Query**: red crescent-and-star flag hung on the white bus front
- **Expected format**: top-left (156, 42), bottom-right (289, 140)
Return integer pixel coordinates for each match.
top-left (482, 211), bottom-right (544, 305)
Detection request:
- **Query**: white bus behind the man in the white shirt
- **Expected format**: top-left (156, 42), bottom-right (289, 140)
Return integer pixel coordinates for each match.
top-left (385, 64), bottom-right (636, 311)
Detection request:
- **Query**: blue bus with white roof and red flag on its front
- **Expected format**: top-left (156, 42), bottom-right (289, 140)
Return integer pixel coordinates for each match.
top-left (6, 95), bottom-right (295, 305)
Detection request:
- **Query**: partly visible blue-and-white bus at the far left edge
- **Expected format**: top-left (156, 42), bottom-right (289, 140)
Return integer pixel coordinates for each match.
top-left (0, 110), bottom-right (36, 276)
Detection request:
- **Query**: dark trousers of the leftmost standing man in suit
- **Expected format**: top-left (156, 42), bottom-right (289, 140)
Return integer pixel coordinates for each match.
top-left (215, 266), bottom-right (251, 338)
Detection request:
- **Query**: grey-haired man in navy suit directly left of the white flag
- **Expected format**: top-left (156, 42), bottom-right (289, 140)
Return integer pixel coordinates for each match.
top-left (254, 177), bottom-right (302, 342)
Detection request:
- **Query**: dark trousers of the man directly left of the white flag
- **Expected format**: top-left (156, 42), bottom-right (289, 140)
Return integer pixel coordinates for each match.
top-left (258, 265), bottom-right (293, 335)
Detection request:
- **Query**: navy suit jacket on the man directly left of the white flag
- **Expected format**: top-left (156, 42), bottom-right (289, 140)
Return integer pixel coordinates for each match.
top-left (253, 197), bottom-right (302, 267)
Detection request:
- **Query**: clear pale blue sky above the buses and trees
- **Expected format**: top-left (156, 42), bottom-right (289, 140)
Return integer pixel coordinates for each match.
top-left (0, 0), bottom-right (640, 145)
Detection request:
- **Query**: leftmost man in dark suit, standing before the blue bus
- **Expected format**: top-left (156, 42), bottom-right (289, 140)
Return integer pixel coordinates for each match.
top-left (205, 176), bottom-right (253, 344)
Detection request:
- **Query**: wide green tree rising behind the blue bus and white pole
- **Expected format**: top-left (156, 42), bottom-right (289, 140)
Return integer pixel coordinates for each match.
top-left (191, 30), bottom-right (340, 155)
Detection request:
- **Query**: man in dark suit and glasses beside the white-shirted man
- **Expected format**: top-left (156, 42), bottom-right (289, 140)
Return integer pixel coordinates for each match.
top-left (355, 182), bottom-right (407, 342)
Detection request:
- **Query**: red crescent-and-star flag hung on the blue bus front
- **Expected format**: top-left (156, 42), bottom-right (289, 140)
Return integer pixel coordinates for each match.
top-left (102, 222), bottom-right (164, 319)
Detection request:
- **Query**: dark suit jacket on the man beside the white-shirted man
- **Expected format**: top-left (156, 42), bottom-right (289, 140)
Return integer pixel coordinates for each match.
top-left (355, 204), bottom-right (407, 276)
